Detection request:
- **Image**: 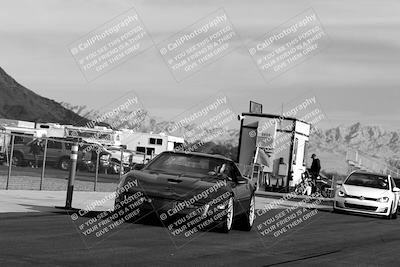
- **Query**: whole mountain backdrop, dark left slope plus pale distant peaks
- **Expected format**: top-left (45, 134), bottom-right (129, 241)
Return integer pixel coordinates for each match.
top-left (0, 68), bottom-right (400, 176)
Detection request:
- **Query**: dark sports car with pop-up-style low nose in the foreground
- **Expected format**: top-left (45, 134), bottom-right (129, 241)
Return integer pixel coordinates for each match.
top-left (114, 151), bottom-right (255, 232)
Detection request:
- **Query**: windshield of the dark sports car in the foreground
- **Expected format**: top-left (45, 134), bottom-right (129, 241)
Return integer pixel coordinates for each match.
top-left (145, 153), bottom-right (226, 178)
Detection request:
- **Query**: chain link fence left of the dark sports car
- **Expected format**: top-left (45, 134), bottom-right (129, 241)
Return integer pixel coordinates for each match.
top-left (0, 131), bottom-right (152, 192)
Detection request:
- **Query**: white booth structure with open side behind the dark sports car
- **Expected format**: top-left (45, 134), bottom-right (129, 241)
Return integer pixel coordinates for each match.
top-left (238, 113), bottom-right (311, 192)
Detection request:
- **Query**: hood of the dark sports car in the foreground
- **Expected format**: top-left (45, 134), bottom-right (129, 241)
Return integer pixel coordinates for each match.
top-left (128, 170), bottom-right (230, 202)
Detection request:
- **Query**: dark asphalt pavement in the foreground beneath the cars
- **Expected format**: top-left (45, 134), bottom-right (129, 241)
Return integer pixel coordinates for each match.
top-left (0, 207), bottom-right (400, 266)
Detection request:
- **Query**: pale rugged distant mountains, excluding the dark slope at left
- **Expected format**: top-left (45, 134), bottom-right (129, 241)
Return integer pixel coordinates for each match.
top-left (62, 100), bottom-right (400, 174)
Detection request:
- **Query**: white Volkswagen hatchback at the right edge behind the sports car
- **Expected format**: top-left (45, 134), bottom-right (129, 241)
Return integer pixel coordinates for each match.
top-left (333, 171), bottom-right (400, 219)
